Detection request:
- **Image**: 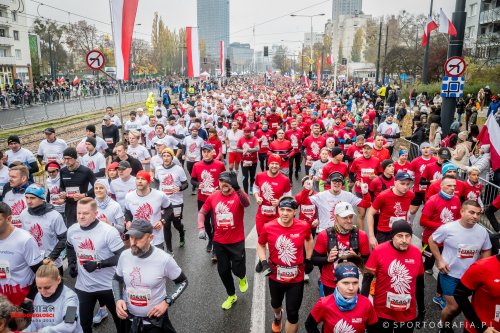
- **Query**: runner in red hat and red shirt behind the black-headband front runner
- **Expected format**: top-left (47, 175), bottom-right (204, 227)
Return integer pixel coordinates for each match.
top-left (253, 154), bottom-right (292, 235)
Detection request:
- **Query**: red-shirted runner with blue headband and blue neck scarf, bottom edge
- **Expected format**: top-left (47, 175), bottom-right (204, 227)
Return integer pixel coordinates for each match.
top-left (305, 262), bottom-right (378, 333)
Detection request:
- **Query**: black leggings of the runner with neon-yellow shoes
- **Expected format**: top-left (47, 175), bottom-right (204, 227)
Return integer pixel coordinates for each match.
top-left (214, 240), bottom-right (247, 296)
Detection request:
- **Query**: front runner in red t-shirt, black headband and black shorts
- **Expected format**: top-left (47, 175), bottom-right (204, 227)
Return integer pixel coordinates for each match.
top-left (257, 196), bottom-right (314, 332)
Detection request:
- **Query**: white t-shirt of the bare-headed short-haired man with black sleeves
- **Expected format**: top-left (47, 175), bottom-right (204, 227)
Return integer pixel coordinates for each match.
top-left (68, 222), bottom-right (123, 292)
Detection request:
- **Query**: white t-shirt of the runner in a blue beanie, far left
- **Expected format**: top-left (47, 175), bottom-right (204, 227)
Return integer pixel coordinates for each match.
top-left (20, 210), bottom-right (67, 267)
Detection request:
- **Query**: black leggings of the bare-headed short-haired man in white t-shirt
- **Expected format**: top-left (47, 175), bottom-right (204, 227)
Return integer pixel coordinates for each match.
top-left (75, 289), bottom-right (122, 333)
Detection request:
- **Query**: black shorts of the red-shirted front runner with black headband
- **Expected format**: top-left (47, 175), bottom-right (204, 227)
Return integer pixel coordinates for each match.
top-left (269, 279), bottom-right (304, 324)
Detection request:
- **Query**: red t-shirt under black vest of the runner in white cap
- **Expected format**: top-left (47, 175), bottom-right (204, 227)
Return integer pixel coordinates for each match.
top-left (314, 230), bottom-right (370, 288)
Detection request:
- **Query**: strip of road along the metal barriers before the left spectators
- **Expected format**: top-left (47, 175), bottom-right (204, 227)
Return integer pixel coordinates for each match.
top-left (0, 89), bottom-right (150, 129)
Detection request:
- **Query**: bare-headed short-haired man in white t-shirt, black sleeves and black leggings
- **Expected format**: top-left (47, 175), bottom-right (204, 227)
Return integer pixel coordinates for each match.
top-left (66, 198), bottom-right (124, 333)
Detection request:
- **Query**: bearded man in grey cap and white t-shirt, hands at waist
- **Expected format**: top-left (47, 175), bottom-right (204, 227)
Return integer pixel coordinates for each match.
top-left (112, 219), bottom-right (188, 333)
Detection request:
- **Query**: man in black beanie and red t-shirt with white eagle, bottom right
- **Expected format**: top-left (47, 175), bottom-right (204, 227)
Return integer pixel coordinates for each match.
top-left (361, 220), bottom-right (425, 333)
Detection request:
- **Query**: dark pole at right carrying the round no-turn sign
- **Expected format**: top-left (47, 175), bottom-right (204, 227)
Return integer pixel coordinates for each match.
top-left (441, 0), bottom-right (467, 135)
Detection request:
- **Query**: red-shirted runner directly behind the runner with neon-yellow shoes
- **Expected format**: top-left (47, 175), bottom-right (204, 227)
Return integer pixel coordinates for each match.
top-left (191, 144), bottom-right (226, 262)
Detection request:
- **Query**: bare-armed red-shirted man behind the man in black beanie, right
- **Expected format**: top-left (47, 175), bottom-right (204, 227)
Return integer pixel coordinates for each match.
top-left (366, 172), bottom-right (415, 248)
